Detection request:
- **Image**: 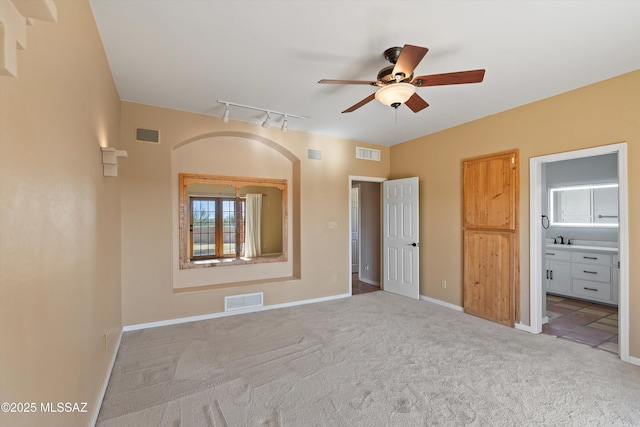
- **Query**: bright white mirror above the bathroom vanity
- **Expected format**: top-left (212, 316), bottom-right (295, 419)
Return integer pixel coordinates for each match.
top-left (549, 184), bottom-right (618, 227)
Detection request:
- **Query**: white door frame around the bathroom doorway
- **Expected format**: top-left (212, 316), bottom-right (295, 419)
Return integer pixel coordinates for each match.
top-left (518, 142), bottom-right (640, 365)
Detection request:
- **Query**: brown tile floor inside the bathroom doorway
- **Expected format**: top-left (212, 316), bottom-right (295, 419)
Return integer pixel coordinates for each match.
top-left (542, 295), bottom-right (618, 354)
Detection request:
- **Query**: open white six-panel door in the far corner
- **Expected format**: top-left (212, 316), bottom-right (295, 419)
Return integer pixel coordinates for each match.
top-left (382, 177), bottom-right (420, 299)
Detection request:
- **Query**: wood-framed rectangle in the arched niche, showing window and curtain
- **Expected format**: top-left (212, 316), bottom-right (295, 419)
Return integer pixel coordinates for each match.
top-left (179, 173), bottom-right (287, 269)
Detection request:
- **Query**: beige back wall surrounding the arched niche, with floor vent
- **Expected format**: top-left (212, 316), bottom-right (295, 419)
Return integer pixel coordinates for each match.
top-left (120, 102), bottom-right (389, 325)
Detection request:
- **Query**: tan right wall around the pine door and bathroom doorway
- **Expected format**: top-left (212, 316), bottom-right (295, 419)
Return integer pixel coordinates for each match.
top-left (391, 71), bottom-right (640, 357)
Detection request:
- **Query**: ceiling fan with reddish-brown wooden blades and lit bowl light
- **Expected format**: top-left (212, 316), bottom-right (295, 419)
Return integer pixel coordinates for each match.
top-left (318, 44), bottom-right (485, 113)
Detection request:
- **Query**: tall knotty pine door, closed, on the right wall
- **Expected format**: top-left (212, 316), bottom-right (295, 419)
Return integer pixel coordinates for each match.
top-left (462, 151), bottom-right (519, 326)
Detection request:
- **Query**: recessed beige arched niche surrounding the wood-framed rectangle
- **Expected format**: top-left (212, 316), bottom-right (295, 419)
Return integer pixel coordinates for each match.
top-left (171, 132), bottom-right (301, 292)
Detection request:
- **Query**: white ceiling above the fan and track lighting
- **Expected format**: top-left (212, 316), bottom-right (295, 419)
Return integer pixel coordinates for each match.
top-left (90, 0), bottom-right (640, 145)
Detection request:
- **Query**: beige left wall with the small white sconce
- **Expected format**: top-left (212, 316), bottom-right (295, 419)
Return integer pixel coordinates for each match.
top-left (0, 0), bottom-right (121, 426)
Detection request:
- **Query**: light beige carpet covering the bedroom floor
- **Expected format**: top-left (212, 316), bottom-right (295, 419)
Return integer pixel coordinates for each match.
top-left (98, 292), bottom-right (640, 427)
